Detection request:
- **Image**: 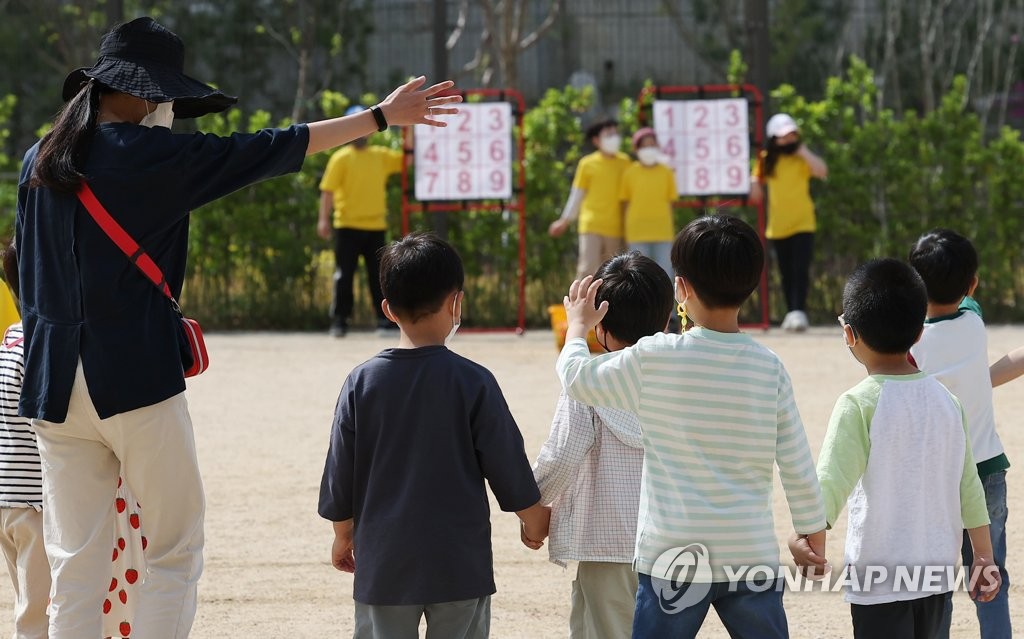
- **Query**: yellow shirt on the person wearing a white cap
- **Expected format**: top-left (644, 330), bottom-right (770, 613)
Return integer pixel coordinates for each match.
top-left (754, 151), bottom-right (817, 240)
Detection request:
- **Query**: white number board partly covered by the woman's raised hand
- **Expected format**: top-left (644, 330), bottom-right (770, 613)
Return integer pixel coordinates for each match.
top-left (414, 102), bottom-right (512, 201)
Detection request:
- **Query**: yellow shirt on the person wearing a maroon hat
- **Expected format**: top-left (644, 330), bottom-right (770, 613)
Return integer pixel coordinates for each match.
top-left (618, 162), bottom-right (676, 242)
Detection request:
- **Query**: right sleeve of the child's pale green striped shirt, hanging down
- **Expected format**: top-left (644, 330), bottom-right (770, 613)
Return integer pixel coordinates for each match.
top-left (775, 368), bottom-right (825, 535)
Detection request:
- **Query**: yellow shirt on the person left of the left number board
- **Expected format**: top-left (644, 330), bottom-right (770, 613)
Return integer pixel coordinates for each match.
top-left (321, 144), bottom-right (402, 230)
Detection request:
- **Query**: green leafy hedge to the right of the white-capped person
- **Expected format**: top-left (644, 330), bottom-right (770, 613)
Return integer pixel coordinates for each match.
top-left (773, 58), bottom-right (1024, 321)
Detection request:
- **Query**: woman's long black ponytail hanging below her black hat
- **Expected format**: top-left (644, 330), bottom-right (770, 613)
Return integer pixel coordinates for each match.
top-left (29, 80), bottom-right (112, 193)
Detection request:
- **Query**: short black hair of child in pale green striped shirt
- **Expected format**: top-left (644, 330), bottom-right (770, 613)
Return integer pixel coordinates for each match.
top-left (672, 215), bottom-right (765, 308)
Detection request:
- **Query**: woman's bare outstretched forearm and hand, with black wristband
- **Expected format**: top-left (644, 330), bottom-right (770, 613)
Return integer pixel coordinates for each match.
top-left (306, 76), bottom-right (462, 156)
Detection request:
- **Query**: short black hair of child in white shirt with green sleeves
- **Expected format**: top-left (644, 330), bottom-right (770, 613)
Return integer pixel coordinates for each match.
top-left (843, 257), bottom-right (928, 354)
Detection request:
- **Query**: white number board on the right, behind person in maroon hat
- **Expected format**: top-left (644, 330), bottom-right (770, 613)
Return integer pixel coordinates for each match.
top-left (654, 98), bottom-right (751, 196)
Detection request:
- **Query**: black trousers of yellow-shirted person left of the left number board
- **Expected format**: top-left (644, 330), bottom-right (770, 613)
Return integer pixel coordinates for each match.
top-left (331, 228), bottom-right (389, 327)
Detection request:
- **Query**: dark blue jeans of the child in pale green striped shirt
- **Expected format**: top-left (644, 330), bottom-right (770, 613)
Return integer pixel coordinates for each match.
top-left (633, 572), bottom-right (790, 639)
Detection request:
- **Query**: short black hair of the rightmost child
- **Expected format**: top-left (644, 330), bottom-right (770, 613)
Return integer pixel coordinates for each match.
top-left (909, 228), bottom-right (978, 304)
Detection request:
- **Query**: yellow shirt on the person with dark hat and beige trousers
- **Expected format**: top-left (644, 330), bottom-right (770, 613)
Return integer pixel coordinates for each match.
top-left (572, 151), bottom-right (630, 238)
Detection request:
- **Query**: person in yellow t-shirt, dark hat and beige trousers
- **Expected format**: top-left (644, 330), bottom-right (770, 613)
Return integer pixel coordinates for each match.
top-left (548, 120), bottom-right (630, 279)
